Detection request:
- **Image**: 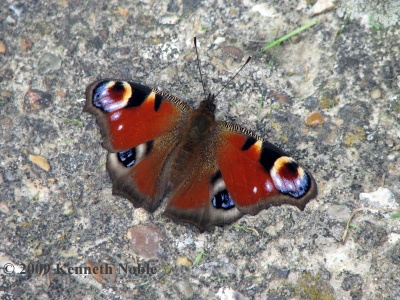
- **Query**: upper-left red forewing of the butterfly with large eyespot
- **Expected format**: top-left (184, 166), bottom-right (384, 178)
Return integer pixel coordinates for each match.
top-left (84, 80), bottom-right (192, 152)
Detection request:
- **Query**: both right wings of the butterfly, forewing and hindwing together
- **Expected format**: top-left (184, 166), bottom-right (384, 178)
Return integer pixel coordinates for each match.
top-left (164, 122), bottom-right (317, 231)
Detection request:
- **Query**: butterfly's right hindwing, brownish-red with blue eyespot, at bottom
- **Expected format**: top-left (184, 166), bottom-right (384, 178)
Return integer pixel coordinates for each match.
top-left (164, 137), bottom-right (243, 231)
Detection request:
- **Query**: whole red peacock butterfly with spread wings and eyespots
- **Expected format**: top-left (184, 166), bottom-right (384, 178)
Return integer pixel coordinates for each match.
top-left (84, 40), bottom-right (318, 231)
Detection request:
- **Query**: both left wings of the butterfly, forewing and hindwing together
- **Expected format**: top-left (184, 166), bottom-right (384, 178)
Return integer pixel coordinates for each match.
top-left (84, 80), bottom-right (192, 212)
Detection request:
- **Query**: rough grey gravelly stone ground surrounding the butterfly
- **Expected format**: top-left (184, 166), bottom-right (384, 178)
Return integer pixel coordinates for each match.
top-left (0, 0), bottom-right (400, 299)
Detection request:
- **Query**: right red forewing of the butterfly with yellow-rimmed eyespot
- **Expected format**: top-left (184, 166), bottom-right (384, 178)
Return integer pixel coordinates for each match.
top-left (216, 122), bottom-right (318, 215)
